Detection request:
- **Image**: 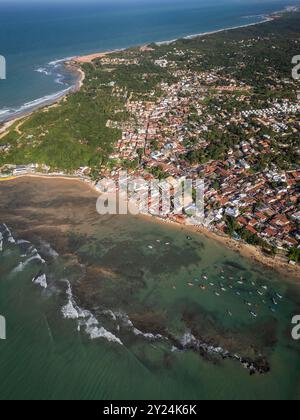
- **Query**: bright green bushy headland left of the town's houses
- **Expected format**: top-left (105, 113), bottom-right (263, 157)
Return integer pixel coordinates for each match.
top-left (0, 66), bottom-right (126, 171)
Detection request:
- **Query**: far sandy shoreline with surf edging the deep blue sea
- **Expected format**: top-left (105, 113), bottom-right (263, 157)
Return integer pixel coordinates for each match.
top-left (0, 5), bottom-right (300, 126)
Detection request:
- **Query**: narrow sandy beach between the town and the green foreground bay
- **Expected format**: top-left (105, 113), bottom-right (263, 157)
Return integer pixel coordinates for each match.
top-left (0, 174), bottom-right (300, 281)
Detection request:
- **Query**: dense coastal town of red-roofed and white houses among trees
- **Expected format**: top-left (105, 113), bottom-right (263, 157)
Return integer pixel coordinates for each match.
top-left (0, 9), bottom-right (300, 264)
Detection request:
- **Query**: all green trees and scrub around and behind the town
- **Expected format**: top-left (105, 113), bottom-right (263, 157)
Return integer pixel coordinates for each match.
top-left (0, 13), bottom-right (300, 172)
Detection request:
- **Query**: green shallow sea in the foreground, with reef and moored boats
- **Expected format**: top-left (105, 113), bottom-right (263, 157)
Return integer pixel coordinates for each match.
top-left (0, 180), bottom-right (300, 399)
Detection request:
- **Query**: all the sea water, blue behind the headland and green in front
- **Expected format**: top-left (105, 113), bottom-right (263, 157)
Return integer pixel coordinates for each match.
top-left (0, 0), bottom-right (300, 400)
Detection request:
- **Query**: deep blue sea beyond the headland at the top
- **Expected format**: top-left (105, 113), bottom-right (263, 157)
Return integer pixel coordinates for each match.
top-left (0, 0), bottom-right (299, 121)
